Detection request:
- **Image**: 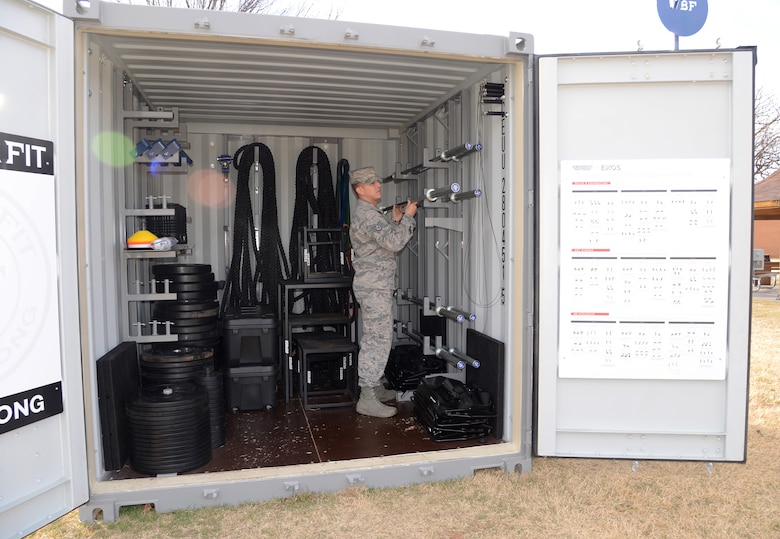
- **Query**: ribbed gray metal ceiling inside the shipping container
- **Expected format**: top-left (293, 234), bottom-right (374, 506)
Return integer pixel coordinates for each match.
top-left (94, 35), bottom-right (506, 129)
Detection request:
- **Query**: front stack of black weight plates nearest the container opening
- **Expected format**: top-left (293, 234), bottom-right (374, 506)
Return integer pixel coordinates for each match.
top-left (125, 383), bottom-right (212, 475)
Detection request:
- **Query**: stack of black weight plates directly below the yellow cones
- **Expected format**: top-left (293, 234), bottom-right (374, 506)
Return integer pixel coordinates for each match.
top-left (152, 264), bottom-right (219, 346)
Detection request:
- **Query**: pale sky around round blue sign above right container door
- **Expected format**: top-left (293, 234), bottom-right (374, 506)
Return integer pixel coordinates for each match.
top-left (317, 0), bottom-right (780, 100)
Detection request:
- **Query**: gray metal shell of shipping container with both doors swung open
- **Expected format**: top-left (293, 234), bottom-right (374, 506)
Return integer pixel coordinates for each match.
top-left (0, 0), bottom-right (756, 537)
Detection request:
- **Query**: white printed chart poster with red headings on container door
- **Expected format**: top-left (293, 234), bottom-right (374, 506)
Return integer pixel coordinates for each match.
top-left (558, 159), bottom-right (731, 380)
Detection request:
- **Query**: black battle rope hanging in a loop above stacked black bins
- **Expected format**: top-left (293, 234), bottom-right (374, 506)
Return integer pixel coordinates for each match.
top-left (220, 143), bottom-right (289, 317)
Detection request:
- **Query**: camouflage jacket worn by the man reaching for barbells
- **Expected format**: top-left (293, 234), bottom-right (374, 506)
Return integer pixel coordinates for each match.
top-left (349, 199), bottom-right (416, 290)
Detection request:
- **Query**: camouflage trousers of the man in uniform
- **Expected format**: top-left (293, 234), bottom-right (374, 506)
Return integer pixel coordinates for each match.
top-left (353, 288), bottom-right (393, 387)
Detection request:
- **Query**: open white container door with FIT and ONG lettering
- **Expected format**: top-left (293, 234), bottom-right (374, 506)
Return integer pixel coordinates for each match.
top-left (0, 0), bottom-right (88, 537)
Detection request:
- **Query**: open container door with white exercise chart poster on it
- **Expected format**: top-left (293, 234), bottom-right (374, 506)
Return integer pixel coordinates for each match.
top-left (536, 48), bottom-right (755, 462)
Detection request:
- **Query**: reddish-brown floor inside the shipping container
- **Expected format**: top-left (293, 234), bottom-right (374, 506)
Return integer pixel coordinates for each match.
top-left (110, 398), bottom-right (499, 479)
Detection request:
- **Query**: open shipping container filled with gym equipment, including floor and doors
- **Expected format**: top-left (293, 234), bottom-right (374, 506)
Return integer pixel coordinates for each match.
top-left (0, 0), bottom-right (756, 537)
